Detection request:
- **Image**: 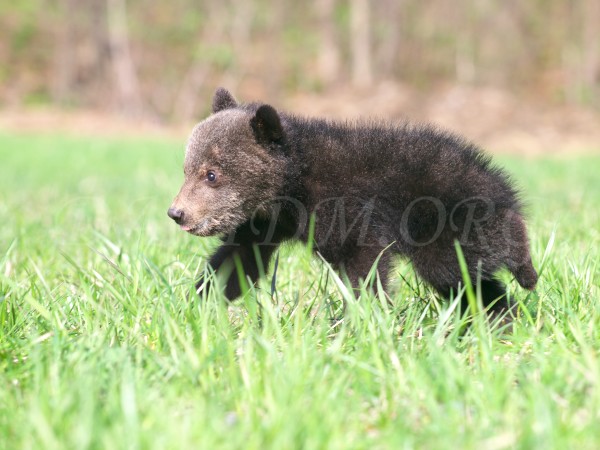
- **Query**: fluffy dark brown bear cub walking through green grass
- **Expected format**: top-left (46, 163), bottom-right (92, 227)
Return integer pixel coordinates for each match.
top-left (168, 88), bottom-right (537, 312)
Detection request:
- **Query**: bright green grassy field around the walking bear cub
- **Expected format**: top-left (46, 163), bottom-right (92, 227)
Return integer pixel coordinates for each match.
top-left (0, 133), bottom-right (600, 450)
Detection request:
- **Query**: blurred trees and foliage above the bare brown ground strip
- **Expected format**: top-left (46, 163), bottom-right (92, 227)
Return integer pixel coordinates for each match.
top-left (0, 0), bottom-right (600, 119)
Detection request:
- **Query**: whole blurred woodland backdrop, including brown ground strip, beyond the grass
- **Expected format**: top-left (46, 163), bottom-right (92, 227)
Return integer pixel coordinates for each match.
top-left (0, 0), bottom-right (600, 154)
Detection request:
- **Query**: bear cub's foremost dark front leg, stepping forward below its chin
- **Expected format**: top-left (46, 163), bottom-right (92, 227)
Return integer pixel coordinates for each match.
top-left (196, 223), bottom-right (278, 300)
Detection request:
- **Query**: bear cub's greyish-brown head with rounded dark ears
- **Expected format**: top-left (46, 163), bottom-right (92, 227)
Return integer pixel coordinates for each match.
top-left (168, 88), bottom-right (285, 236)
